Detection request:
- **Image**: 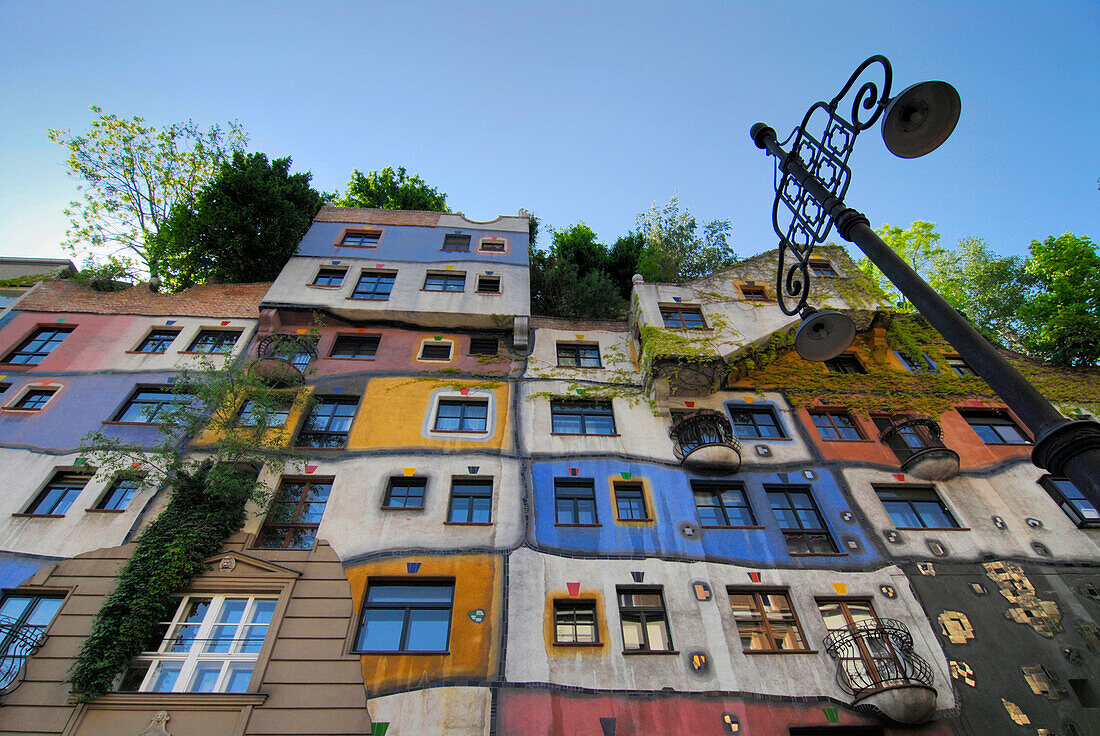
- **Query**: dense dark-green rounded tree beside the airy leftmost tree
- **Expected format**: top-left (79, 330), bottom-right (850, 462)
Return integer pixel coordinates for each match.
top-left (150, 153), bottom-right (322, 290)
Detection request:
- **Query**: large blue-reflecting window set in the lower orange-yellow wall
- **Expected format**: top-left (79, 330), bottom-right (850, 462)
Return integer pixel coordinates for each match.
top-left (355, 580), bottom-right (454, 652)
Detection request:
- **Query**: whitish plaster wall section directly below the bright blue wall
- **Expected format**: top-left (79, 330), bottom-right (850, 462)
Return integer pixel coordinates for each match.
top-left (506, 549), bottom-right (955, 710)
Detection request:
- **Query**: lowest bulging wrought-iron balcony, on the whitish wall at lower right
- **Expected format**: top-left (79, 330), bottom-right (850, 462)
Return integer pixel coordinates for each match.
top-left (824, 618), bottom-right (936, 723)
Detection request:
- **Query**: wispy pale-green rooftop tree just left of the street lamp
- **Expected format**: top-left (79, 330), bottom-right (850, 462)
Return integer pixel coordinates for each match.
top-left (638, 197), bottom-right (737, 283)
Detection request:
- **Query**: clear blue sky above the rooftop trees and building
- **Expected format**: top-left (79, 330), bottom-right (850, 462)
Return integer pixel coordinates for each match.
top-left (0, 0), bottom-right (1100, 264)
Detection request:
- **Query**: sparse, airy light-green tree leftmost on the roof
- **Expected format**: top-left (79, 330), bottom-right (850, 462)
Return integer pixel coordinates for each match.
top-left (46, 106), bottom-right (248, 278)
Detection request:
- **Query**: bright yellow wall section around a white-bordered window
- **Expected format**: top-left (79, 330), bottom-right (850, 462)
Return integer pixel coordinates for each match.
top-left (348, 377), bottom-right (512, 450)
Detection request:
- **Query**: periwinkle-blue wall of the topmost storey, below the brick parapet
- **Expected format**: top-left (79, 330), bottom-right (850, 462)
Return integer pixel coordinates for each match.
top-left (297, 222), bottom-right (527, 266)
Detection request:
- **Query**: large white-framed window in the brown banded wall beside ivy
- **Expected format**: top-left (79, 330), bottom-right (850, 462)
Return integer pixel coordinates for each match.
top-left (119, 595), bottom-right (276, 693)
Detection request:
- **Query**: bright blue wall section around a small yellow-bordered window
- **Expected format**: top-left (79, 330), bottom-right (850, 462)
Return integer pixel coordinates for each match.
top-left (530, 459), bottom-right (886, 570)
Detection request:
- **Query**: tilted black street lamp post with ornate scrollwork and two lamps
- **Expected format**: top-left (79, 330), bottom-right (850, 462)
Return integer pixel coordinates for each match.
top-left (751, 55), bottom-right (1100, 508)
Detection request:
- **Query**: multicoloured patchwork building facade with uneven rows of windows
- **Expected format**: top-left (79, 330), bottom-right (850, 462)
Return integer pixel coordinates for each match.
top-left (0, 208), bottom-right (1100, 736)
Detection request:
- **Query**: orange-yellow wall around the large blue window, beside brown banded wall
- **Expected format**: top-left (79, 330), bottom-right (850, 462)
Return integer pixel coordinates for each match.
top-left (344, 554), bottom-right (502, 695)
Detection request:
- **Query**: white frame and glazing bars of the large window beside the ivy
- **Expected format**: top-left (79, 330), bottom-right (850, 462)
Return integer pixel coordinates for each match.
top-left (123, 593), bottom-right (279, 693)
